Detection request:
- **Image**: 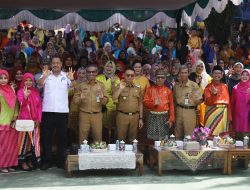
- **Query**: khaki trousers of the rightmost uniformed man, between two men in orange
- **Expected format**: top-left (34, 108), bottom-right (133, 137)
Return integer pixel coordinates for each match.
top-left (175, 106), bottom-right (196, 140)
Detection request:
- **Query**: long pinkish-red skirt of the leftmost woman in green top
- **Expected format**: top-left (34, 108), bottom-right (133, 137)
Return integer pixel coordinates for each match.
top-left (0, 128), bottom-right (18, 168)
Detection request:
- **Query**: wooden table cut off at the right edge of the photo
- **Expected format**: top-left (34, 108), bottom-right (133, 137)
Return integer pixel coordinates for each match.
top-left (227, 147), bottom-right (250, 174)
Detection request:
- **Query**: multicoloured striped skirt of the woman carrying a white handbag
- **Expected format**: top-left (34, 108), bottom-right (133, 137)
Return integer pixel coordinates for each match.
top-left (18, 127), bottom-right (40, 163)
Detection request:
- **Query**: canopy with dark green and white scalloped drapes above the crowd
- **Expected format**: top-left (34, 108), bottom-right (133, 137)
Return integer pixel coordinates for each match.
top-left (0, 0), bottom-right (242, 32)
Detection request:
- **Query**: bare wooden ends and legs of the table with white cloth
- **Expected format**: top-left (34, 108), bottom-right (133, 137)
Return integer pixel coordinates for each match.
top-left (66, 152), bottom-right (144, 177)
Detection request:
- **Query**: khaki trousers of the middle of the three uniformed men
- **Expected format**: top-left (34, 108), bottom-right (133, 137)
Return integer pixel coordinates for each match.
top-left (116, 111), bottom-right (139, 143)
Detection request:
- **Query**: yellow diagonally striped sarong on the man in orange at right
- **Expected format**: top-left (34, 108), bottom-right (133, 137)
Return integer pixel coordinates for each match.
top-left (205, 105), bottom-right (228, 136)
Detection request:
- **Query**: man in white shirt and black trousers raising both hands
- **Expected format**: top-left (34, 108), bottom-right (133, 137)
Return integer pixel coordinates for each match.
top-left (37, 56), bottom-right (74, 170)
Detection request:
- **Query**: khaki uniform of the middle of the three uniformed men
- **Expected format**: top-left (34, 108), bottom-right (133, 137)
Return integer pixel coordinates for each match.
top-left (116, 85), bottom-right (143, 142)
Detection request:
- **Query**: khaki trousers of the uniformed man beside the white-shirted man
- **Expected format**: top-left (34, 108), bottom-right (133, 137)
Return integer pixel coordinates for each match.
top-left (79, 111), bottom-right (102, 144)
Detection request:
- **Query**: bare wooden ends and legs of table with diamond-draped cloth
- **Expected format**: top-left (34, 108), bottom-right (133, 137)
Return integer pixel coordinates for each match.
top-left (149, 146), bottom-right (228, 176)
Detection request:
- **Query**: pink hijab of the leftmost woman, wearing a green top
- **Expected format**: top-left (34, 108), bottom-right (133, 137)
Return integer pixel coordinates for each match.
top-left (0, 69), bottom-right (16, 109)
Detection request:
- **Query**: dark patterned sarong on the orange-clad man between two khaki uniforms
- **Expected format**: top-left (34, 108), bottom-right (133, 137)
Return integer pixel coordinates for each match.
top-left (147, 111), bottom-right (169, 140)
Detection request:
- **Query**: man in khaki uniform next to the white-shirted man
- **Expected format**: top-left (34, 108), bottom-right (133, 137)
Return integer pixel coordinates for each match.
top-left (73, 65), bottom-right (108, 143)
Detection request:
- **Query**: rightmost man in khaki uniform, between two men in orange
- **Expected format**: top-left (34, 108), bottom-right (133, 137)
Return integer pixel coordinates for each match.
top-left (174, 65), bottom-right (202, 140)
